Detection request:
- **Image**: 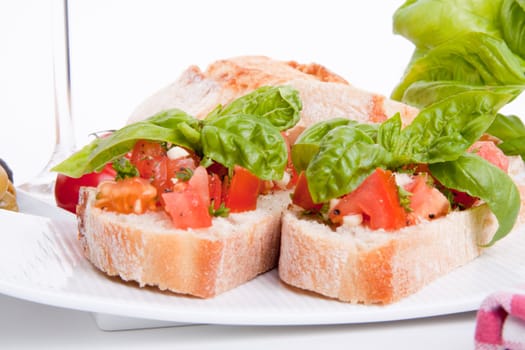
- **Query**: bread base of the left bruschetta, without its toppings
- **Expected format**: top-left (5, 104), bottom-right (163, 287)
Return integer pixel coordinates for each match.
top-left (77, 188), bottom-right (289, 298)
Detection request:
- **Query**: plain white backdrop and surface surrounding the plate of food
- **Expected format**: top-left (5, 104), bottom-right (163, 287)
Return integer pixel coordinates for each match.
top-left (0, 0), bottom-right (522, 349)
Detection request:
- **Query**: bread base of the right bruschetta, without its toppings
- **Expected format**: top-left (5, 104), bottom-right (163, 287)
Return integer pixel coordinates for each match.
top-left (279, 159), bottom-right (525, 304)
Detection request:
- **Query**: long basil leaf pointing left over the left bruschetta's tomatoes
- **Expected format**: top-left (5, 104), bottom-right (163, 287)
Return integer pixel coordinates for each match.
top-left (52, 109), bottom-right (200, 177)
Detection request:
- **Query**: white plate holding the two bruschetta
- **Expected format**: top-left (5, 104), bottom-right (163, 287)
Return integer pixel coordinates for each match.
top-left (0, 193), bottom-right (525, 325)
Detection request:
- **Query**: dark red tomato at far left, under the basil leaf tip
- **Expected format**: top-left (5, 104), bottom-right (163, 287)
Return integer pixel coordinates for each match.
top-left (55, 164), bottom-right (116, 213)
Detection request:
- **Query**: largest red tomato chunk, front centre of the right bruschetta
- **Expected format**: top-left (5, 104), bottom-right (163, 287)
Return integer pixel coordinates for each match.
top-left (329, 168), bottom-right (407, 230)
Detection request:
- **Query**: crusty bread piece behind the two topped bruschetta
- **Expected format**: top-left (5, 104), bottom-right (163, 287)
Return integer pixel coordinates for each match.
top-left (128, 56), bottom-right (418, 141)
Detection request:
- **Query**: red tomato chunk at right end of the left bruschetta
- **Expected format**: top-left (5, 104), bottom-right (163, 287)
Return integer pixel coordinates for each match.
top-left (224, 165), bottom-right (262, 213)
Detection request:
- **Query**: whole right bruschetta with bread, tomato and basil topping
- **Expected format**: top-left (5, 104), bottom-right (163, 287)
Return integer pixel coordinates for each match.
top-left (279, 91), bottom-right (525, 304)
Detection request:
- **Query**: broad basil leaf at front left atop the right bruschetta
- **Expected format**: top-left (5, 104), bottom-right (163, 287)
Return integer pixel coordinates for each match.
top-left (306, 125), bottom-right (389, 203)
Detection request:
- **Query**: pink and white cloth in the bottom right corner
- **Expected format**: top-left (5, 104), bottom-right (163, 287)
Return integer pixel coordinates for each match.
top-left (475, 286), bottom-right (525, 350)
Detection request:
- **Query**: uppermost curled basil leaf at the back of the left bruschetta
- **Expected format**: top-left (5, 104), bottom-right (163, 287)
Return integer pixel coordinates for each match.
top-left (207, 86), bottom-right (302, 131)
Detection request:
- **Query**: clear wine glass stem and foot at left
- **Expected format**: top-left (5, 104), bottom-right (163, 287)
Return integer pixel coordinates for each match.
top-left (17, 0), bottom-right (75, 204)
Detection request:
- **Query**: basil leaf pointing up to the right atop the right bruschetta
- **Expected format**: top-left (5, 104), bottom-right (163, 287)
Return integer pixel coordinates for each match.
top-left (386, 91), bottom-right (512, 167)
